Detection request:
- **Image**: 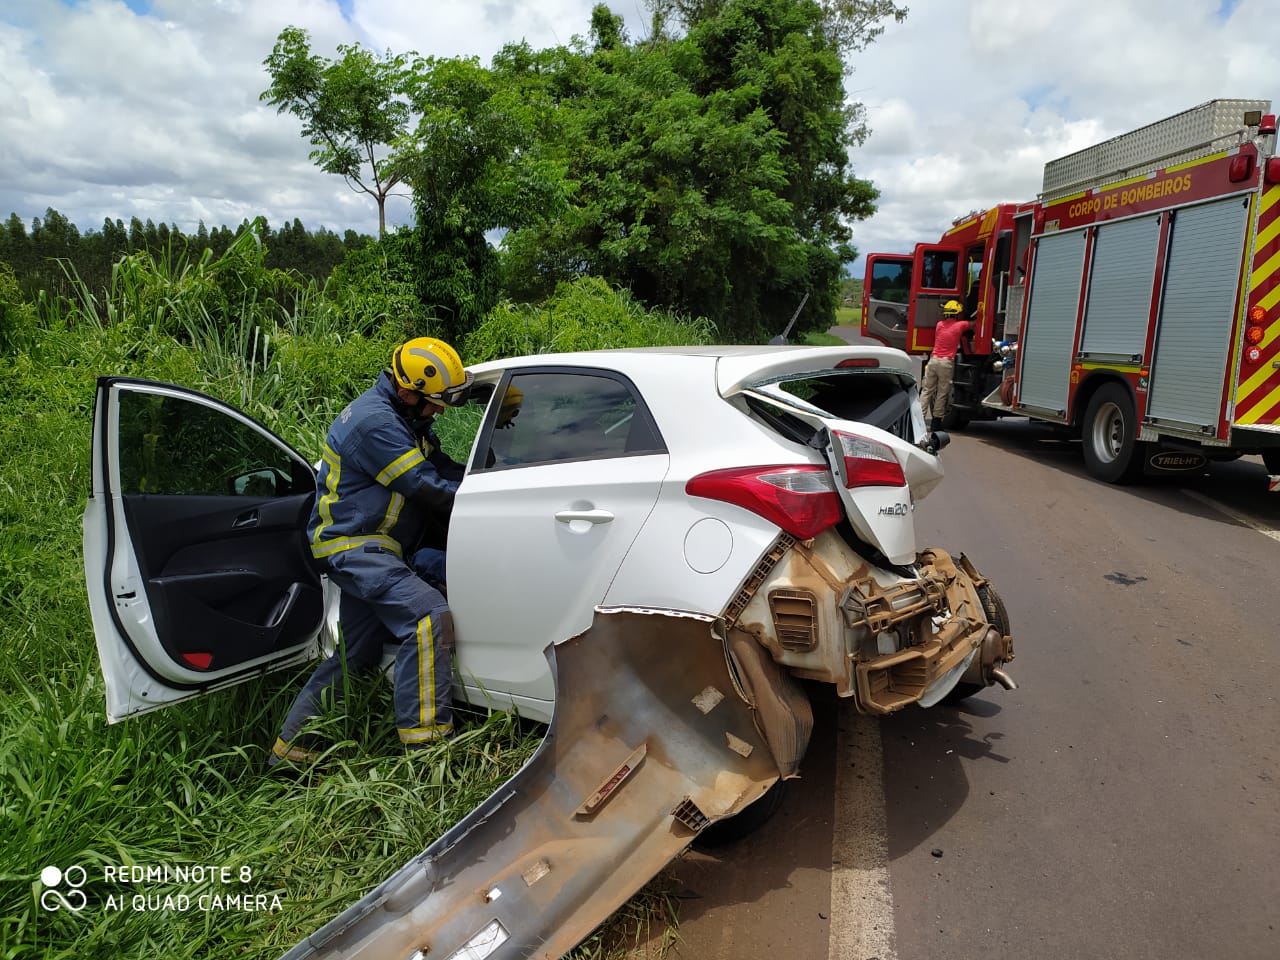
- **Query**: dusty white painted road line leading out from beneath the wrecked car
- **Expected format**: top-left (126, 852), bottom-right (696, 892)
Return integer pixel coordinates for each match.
top-left (827, 703), bottom-right (897, 960)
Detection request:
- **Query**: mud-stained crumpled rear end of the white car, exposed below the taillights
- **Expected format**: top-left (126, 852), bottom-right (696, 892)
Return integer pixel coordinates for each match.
top-left (726, 531), bottom-right (1014, 714)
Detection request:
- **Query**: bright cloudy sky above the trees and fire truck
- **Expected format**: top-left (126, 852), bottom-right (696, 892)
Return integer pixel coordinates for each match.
top-left (0, 0), bottom-right (1280, 273)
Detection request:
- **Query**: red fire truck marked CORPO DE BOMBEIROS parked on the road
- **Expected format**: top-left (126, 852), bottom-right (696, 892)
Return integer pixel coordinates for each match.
top-left (861, 100), bottom-right (1280, 490)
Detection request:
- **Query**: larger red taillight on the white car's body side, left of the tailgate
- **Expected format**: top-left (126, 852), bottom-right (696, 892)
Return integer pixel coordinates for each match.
top-left (685, 465), bottom-right (845, 540)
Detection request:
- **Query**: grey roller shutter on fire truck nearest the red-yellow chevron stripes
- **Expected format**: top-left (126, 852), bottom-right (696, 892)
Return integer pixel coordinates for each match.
top-left (1147, 197), bottom-right (1248, 429)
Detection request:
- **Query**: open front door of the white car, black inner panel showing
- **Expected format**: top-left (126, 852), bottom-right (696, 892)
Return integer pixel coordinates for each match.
top-left (84, 376), bottom-right (326, 723)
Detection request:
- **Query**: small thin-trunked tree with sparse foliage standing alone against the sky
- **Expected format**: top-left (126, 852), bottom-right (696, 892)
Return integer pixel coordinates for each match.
top-left (260, 27), bottom-right (413, 237)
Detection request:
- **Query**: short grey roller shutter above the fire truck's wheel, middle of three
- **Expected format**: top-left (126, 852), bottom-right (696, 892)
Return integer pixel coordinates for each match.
top-left (1080, 216), bottom-right (1160, 362)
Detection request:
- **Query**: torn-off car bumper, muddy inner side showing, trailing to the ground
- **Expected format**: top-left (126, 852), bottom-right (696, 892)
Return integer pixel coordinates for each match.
top-left (284, 608), bottom-right (798, 960)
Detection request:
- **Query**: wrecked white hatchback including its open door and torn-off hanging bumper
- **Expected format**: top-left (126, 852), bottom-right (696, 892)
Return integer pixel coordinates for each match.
top-left (84, 346), bottom-right (1012, 957)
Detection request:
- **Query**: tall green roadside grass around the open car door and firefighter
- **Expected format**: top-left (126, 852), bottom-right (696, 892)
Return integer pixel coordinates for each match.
top-left (0, 249), bottom-right (709, 960)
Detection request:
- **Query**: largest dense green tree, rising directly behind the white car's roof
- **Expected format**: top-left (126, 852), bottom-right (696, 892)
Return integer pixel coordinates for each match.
top-left (495, 0), bottom-right (901, 339)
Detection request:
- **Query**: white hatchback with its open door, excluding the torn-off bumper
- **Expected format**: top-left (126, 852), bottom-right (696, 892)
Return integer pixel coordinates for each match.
top-left (84, 346), bottom-right (1011, 722)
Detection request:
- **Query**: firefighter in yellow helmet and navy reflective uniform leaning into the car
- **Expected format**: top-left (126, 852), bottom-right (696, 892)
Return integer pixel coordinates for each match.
top-left (269, 337), bottom-right (471, 771)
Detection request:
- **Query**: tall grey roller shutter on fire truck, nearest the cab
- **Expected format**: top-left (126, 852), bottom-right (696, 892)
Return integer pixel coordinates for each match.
top-left (1018, 230), bottom-right (1084, 411)
